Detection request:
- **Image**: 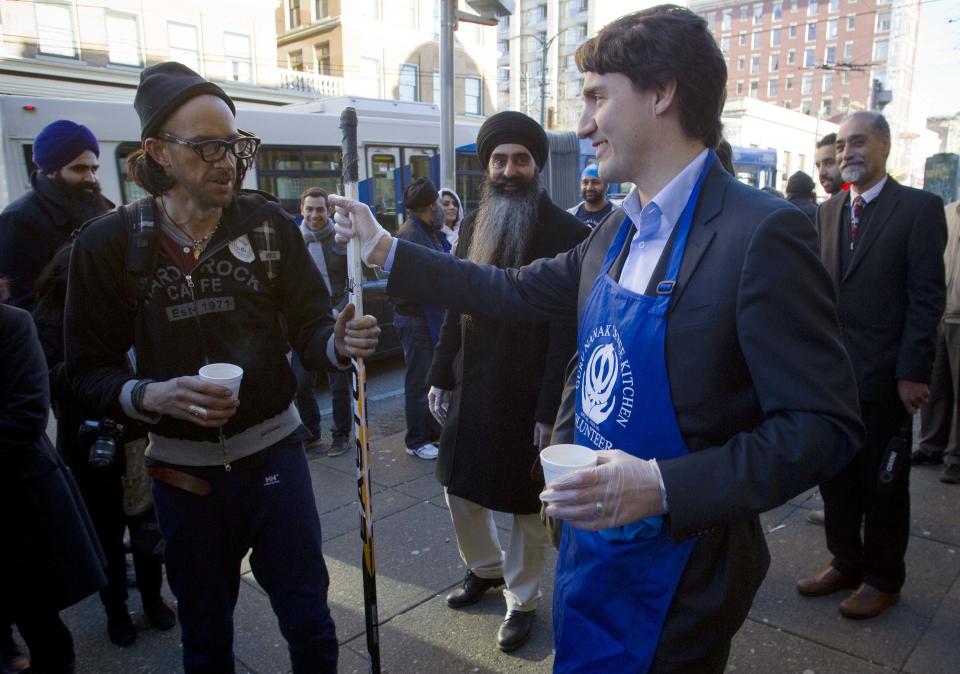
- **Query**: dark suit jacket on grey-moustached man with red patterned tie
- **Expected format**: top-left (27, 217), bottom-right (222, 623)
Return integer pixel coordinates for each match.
top-left (816, 177), bottom-right (947, 402)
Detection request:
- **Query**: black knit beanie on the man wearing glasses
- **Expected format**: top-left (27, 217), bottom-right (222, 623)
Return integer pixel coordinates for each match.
top-left (133, 61), bottom-right (237, 141)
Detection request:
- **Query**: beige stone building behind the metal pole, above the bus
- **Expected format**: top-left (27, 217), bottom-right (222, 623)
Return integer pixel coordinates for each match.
top-left (275, 0), bottom-right (498, 117)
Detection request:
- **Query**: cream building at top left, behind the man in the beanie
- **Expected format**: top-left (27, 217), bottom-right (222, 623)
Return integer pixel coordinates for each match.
top-left (0, 0), bottom-right (311, 105)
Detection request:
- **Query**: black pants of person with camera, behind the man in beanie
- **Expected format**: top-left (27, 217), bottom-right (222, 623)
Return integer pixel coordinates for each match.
top-left (74, 465), bottom-right (163, 614)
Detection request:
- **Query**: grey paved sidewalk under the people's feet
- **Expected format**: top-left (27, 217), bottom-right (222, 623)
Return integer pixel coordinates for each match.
top-left (63, 433), bottom-right (960, 674)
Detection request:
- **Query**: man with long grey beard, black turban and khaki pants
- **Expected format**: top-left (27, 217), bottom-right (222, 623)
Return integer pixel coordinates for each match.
top-left (427, 112), bottom-right (589, 651)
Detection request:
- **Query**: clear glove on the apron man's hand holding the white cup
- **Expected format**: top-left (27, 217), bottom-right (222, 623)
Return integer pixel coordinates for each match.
top-left (540, 449), bottom-right (663, 531)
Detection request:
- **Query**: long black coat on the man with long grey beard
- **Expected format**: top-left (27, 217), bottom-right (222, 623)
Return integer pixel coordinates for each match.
top-left (427, 192), bottom-right (590, 514)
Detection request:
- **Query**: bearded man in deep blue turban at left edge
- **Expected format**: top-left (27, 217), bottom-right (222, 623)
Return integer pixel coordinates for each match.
top-left (0, 119), bottom-right (113, 311)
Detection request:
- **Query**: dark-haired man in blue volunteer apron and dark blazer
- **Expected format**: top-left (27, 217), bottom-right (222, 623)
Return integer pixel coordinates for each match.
top-left (331, 6), bottom-right (863, 674)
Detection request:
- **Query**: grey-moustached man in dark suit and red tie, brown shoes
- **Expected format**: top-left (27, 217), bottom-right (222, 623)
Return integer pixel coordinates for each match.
top-left (797, 112), bottom-right (947, 619)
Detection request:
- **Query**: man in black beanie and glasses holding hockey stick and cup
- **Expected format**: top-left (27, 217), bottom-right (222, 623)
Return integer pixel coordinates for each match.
top-left (64, 63), bottom-right (380, 674)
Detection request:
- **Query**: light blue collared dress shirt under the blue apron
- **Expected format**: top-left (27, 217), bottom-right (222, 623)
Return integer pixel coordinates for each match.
top-left (620, 150), bottom-right (708, 294)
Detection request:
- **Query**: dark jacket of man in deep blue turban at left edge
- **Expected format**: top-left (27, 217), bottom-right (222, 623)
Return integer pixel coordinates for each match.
top-left (0, 172), bottom-right (113, 311)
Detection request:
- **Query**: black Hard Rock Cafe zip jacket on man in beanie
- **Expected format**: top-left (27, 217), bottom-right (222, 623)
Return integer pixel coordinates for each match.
top-left (64, 192), bottom-right (333, 442)
